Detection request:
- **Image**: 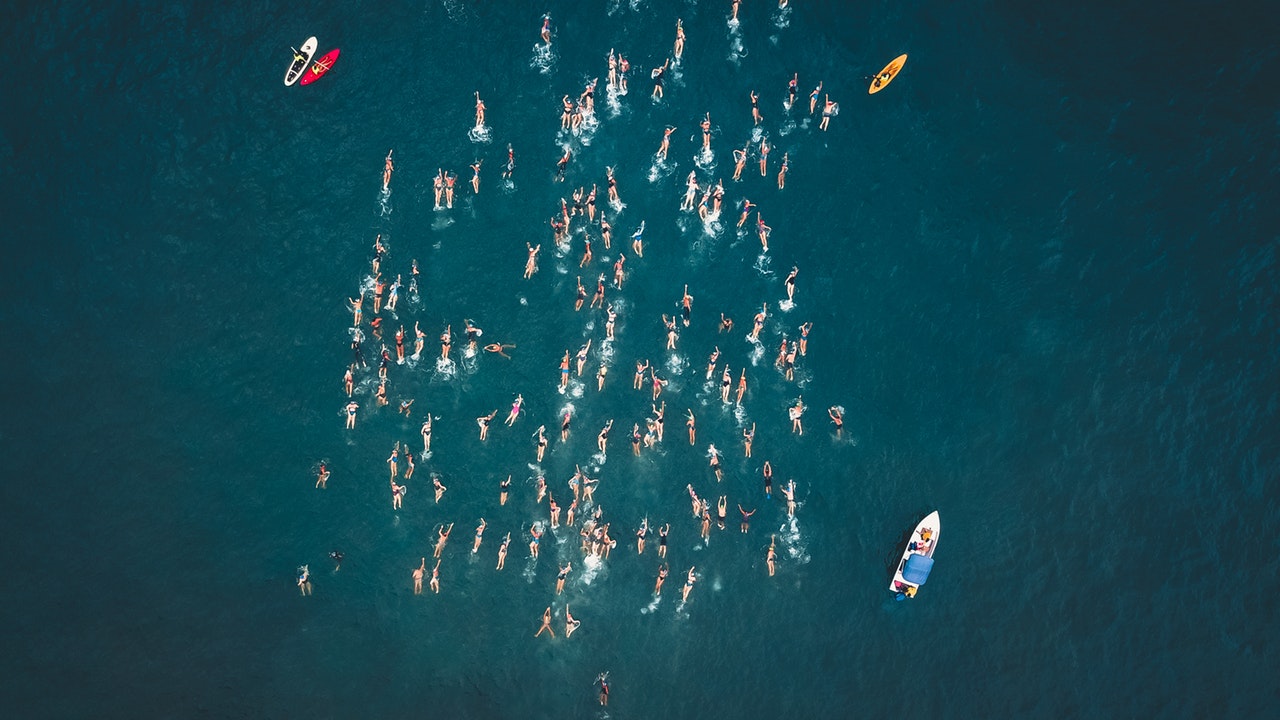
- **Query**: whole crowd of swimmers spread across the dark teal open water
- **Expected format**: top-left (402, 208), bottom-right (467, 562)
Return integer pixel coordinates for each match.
top-left (308, 0), bottom-right (844, 705)
